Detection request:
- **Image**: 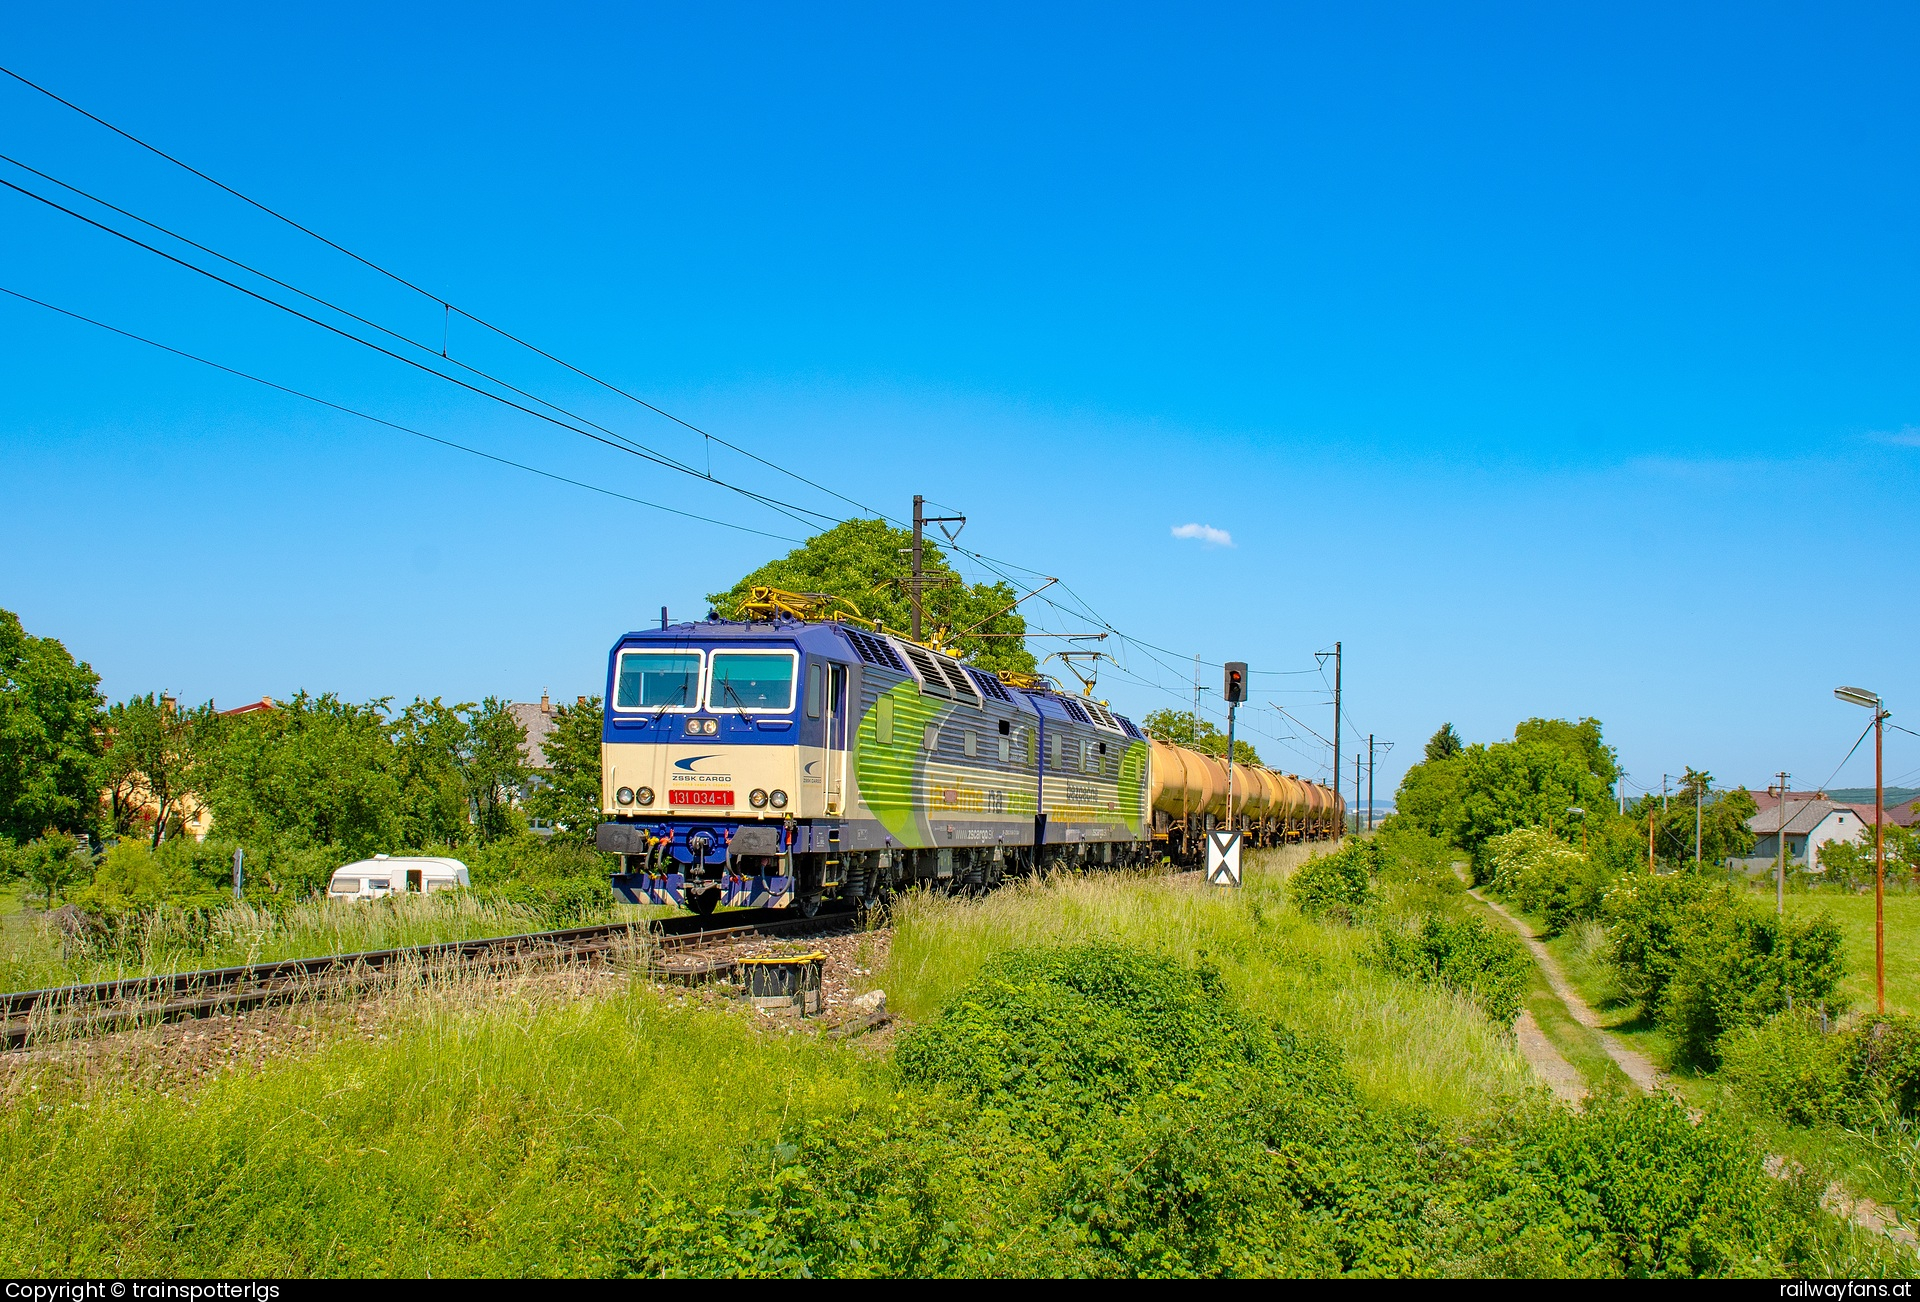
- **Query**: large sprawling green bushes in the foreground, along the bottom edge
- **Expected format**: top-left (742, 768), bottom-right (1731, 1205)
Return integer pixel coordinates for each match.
top-left (620, 945), bottom-right (1843, 1279)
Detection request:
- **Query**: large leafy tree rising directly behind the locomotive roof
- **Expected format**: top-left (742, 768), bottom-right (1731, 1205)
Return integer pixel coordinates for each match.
top-left (707, 520), bottom-right (1035, 672)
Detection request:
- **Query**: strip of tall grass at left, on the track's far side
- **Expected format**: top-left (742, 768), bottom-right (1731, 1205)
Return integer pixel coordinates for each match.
top-left (0, 891), bottom-right (664, 991)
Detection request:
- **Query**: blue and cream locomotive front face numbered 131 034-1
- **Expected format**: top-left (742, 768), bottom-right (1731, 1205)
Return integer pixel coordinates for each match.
top-left (595, 622), bottom-right (847, 912)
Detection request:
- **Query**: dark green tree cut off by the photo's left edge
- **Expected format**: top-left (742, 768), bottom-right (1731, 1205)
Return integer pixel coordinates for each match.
top-left (0, 611), bottom-right (104, 841)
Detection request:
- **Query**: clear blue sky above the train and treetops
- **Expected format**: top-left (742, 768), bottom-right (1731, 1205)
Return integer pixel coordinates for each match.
top-left (0, 4), bottom-right (1920, 806)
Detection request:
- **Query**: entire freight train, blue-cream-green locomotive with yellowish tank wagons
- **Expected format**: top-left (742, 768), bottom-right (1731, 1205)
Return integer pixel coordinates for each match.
top-left (595, 610), bottom-right (1342, 912)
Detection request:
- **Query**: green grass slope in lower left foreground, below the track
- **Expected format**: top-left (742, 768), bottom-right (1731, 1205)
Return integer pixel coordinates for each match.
top-left (0, 979), bottom-right (891, 1277)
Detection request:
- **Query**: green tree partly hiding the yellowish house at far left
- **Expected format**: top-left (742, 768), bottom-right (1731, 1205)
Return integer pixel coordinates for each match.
top-left (98, 691), bottom-right (217, 847)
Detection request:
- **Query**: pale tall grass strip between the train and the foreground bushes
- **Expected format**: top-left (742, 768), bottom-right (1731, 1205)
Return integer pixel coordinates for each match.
top-left (876, 862), bottom-right (1530, 1118)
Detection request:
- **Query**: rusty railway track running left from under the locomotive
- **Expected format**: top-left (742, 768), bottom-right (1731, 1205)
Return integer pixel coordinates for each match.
top-left (0, 908), bottom-right (856, 1049)
